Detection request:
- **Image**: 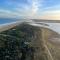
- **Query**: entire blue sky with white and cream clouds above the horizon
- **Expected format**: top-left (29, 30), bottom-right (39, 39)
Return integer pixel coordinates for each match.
top-left (0, 0), bottom-right (60, 20)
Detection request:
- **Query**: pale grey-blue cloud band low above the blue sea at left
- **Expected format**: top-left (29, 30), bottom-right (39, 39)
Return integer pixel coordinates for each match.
top-left (0, 9), bottom-right (30, 18)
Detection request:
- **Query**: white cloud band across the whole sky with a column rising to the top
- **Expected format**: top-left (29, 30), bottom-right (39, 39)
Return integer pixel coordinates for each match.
top-left (0, 0), bottom-right (60, 19)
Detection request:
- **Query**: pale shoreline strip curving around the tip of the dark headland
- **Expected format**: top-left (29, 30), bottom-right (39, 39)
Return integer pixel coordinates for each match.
top-left (0, 20), bottom-right (60, 34)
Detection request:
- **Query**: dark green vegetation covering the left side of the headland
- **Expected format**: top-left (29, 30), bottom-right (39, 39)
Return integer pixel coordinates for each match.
top-left (0, 24), bottom-right (42, 60)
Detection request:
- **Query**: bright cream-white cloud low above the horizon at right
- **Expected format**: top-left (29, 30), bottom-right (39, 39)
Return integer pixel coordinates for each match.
top-left (39, 10), bottom-right (60, 20)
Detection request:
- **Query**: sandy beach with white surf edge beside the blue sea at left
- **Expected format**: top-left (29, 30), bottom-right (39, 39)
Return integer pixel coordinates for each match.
top-left (0, 21), bottom-right (23, 32)
